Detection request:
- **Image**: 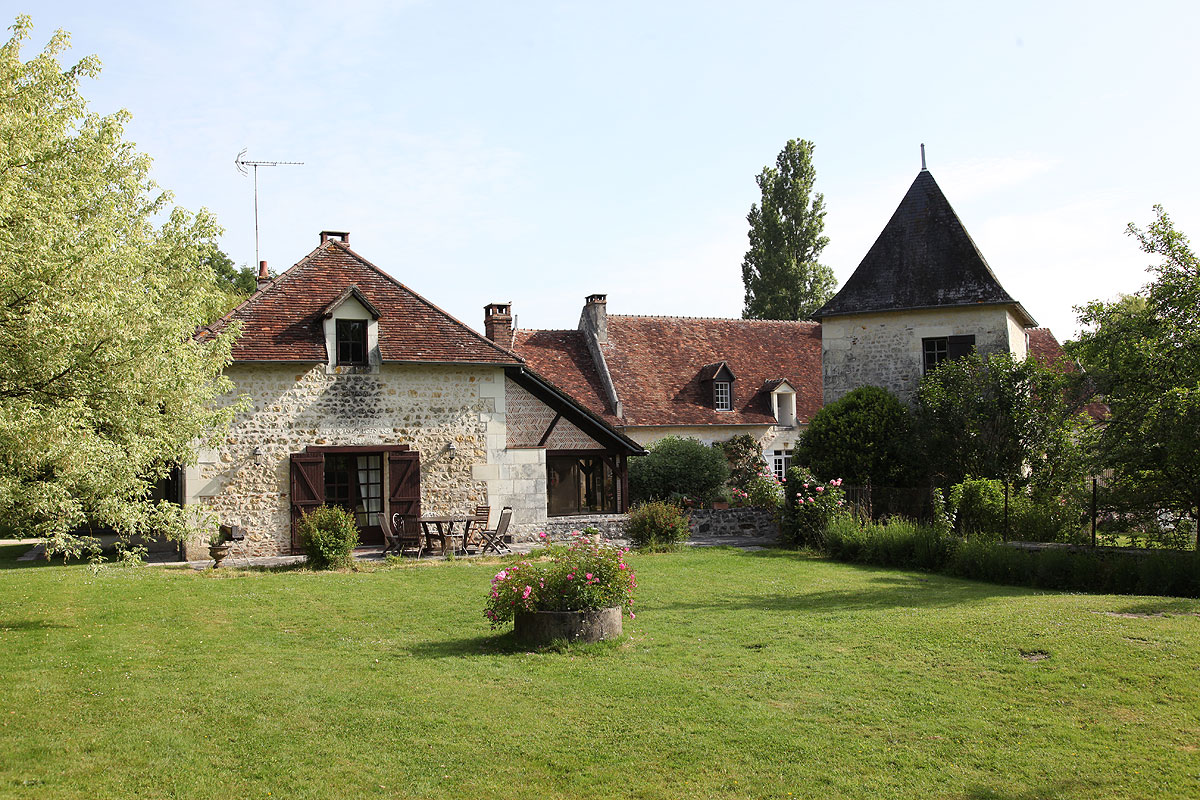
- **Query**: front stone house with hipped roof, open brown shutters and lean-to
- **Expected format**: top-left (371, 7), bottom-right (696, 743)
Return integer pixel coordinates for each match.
top-left (189, 231), bottom-right (643, 557)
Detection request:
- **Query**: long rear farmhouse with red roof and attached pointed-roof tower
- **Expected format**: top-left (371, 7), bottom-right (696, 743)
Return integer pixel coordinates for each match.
top-left (506, 169), bottom-right (1066, 475)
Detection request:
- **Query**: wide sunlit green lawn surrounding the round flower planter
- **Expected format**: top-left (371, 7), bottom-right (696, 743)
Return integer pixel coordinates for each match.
top-left (0, 546), bottom-right (1200, 800)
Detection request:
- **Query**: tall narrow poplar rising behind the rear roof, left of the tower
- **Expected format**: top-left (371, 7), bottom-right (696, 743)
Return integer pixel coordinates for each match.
top-left (742, 139), bottom-right (836, 319)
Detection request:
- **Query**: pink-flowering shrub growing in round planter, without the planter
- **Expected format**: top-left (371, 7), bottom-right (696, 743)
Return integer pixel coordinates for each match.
top-left (484, 534), bottom-right (637, 628)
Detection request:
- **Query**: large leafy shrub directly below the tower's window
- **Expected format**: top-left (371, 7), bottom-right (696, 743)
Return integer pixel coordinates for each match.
top-left (916, 351), bottom-right (1091, 494)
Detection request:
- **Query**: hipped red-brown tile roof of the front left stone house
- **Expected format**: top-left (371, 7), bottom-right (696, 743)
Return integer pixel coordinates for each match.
top-left (198, 240), bottom-right (522, 365)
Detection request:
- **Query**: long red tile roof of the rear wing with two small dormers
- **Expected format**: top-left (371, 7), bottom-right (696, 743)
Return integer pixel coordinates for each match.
top-left (514, 314), bottom-right (822, 426)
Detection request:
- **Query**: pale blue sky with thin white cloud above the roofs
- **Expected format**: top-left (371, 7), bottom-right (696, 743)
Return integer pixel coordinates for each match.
top-left (16, 0), bottom-right (1200, 339)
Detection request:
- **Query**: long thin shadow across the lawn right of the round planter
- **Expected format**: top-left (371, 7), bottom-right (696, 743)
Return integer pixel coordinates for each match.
top-left (654, 573), bottom-right (1036, 614)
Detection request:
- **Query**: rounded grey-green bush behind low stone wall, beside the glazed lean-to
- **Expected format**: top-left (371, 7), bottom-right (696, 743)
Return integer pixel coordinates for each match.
top-left (629, 437), bottom-right (730, 505)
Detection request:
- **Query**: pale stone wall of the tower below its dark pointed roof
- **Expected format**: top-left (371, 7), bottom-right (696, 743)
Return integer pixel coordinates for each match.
top-left (821, 306), bottom-right (1025, 404)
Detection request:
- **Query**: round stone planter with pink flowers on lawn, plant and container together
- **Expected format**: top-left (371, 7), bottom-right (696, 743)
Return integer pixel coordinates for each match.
top-left (484, 534), bottom-right (637, 646)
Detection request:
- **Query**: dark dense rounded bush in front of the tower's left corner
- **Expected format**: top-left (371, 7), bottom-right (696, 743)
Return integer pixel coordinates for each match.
top-left (794, 386), bottom-right (912, 486)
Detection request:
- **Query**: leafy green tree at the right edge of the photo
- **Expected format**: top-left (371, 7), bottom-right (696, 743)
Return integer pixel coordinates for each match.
top-left (1072, 206), bottom-right (1200, 537)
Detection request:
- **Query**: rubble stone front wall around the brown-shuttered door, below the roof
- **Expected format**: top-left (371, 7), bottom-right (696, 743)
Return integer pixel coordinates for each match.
top-left (186, 362), bottom-right (508, 558)
